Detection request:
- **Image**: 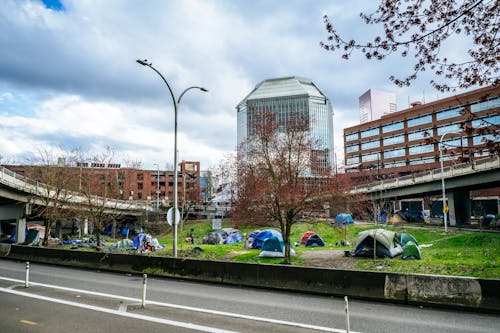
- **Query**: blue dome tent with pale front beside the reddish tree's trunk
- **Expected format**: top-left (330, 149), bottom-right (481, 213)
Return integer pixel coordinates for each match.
top-left (245, 229), bottom-right (295, 258)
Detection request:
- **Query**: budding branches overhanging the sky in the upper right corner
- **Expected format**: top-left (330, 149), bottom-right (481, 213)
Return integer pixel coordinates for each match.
top-left (320, 0), bottom-right (500, 92)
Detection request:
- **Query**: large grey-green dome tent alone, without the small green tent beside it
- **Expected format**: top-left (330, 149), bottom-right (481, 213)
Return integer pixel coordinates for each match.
top-left (353, 229), bottom-right (403, 258)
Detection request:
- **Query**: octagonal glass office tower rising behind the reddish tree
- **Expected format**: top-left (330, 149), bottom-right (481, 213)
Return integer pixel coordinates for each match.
top-left (236, 76), bottom-right (334, 172)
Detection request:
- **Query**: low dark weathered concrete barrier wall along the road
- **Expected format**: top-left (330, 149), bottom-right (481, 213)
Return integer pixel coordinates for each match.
top-left (0, 245), bottom-right (500, 313)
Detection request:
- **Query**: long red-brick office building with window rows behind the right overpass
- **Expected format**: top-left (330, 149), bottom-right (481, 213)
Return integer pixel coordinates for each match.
top-left (344, 86), bottom-right (500, 183)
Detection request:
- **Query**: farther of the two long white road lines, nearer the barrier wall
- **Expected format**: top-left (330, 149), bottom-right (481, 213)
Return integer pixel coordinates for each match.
top-left (0, 277), bottom-right (361, 333)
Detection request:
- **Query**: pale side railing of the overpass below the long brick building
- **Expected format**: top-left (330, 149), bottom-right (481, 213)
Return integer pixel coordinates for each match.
top-left (351, 156), bottom-right (500, 193)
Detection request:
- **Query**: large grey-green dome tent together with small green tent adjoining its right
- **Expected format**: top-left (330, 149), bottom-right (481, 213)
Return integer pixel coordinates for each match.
top-left (351, 228), bottom-right (421, 259)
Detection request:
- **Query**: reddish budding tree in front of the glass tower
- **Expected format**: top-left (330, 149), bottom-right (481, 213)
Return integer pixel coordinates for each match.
top-left (233, 111), bottom-right (340, 264)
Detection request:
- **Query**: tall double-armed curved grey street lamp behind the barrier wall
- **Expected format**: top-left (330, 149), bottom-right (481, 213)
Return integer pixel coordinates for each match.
top-left (136, 59), bottom-right (208, 257)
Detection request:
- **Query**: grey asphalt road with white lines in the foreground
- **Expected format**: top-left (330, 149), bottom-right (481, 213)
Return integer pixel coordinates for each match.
top-left (0, 260), bottom-right (500, 333)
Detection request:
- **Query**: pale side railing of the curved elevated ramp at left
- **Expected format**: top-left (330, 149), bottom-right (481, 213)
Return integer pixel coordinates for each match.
top-left (0, 166), bottom-right (155, 212)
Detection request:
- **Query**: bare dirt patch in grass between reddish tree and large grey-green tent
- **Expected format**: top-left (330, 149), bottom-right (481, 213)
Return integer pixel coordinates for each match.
top-left (300, 250), bottom-right (358, 269)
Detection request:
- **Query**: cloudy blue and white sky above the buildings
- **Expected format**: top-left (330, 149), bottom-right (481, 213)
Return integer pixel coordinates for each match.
top-left (0, 0), bottom-right (472, 170)
